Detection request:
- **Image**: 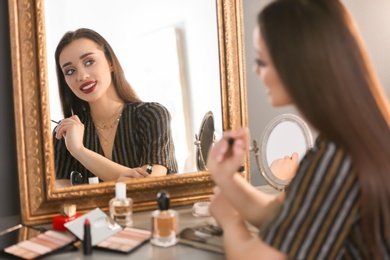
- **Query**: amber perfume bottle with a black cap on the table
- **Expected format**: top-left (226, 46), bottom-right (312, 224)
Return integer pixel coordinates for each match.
top-left (150, 190), bottom-right (179, 247)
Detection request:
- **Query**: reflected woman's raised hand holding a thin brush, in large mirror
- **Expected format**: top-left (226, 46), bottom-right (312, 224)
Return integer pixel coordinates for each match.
top-left (55, 116), bottom-right (84, 157)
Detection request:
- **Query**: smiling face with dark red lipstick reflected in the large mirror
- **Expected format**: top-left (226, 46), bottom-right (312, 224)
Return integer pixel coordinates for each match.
top-left (59, 38), bottom-right (115, 102)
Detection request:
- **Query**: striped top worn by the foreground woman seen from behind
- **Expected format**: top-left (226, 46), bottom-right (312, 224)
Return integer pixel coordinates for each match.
top-left (260, 138), bottom-right (390, 260)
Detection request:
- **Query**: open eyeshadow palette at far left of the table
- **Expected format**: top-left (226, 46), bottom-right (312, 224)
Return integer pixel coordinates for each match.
top-left (0, 225), bottom-right (75, 259)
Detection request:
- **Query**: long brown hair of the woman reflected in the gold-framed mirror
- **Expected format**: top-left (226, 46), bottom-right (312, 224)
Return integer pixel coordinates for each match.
top-left (55, 28), bottom-right (141, 117)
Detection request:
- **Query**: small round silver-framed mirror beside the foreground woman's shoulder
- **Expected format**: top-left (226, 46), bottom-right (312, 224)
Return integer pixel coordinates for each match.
top-left (252, 114), bottom-right (313, 190)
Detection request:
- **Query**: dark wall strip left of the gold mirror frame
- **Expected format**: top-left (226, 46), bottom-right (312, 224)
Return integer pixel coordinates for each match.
top-left (0, 0), bottom-right (20, 217)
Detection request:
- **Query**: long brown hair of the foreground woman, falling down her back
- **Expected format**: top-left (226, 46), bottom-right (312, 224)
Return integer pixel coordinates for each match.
top-left (257, 0), bottom-right (390, 256)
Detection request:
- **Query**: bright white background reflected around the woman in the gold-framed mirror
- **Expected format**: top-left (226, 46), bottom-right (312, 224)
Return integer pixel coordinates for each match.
top-left (45, 0), bottom-right (222, 176)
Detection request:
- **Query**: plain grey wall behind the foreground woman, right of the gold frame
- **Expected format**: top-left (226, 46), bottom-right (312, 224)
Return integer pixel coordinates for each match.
top-left (243, 0), bottom-right (390, 185)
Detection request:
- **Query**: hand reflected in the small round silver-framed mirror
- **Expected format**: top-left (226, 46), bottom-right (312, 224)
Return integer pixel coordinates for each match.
top-left (270, 152), bottom-right (299, 180)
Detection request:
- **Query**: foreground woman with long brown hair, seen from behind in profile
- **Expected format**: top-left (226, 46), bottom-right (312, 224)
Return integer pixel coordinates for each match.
top-left (208, 0), bottom-right (390, 259)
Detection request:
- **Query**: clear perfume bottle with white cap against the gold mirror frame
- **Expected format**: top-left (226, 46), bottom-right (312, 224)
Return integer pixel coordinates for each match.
top-left (109, 182), bottom-right (133, 227)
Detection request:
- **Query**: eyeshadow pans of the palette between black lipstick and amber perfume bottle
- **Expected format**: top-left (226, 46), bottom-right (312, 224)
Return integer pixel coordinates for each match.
top-left (95, 227), bottom-right (151, 254)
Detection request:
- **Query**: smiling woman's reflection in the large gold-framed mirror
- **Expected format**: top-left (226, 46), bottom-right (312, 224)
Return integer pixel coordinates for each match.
top-left (53, 28), bottom-right (177, 183)
